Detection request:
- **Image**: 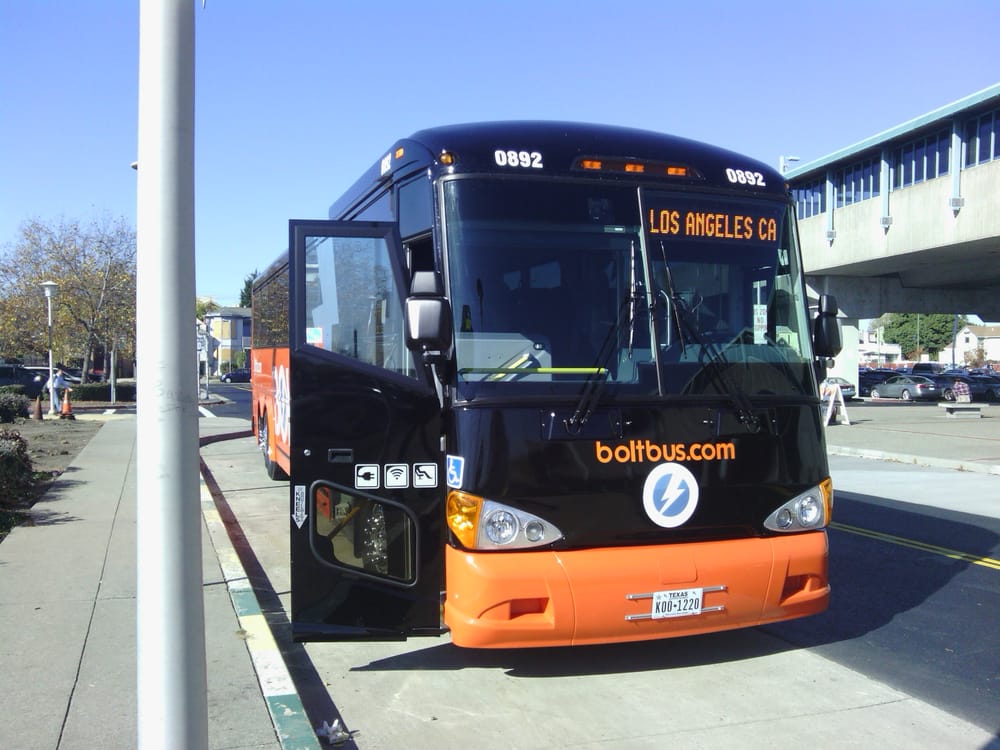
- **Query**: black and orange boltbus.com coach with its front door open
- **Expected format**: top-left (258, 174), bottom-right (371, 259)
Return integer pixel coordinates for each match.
top-left (252, 122), bottom-right (840, 647)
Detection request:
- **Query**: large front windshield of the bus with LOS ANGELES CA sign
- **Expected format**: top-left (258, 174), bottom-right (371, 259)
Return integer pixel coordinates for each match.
top-left (444, 178), bottom-right (815, 400)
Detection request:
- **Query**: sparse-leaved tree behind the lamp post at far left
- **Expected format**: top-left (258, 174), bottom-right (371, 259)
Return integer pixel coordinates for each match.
top-left (0, 219), bottom-right (136, 382)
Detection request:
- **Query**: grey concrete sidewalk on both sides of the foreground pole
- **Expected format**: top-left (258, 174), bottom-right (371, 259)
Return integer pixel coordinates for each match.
top-left (0, 415), bottom-right (296, 750)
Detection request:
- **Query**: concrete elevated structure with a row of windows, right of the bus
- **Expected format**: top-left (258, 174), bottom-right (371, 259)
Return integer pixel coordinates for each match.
top-left (782, 84), bottom-right (1000, 380)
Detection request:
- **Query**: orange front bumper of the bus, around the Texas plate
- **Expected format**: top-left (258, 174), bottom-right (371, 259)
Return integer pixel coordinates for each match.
top-left (444, 531), bottom-right (830, 648)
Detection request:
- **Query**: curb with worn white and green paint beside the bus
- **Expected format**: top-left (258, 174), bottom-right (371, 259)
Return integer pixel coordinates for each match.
top-left (199, 431), bottom-right (320, 750)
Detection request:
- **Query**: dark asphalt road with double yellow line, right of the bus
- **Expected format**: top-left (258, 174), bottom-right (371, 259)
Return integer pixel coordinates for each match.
top-left (765, 456), bottom-right (1000, 732)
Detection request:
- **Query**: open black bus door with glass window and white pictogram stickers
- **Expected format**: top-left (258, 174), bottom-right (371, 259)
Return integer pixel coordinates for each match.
top-left (288, 220), bottom-right (445, 641)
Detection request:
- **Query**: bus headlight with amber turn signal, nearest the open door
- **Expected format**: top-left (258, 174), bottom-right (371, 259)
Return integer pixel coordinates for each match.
top-left (447, 490), bottom-right (562, 549)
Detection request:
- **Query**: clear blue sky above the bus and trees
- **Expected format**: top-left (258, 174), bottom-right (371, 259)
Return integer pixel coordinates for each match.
top-left (0, 0), bottom-right (1000, 304)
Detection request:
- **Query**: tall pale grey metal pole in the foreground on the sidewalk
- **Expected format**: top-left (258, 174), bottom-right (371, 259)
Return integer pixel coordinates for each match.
top-left (136, 0), bottom-right (208, 750)
